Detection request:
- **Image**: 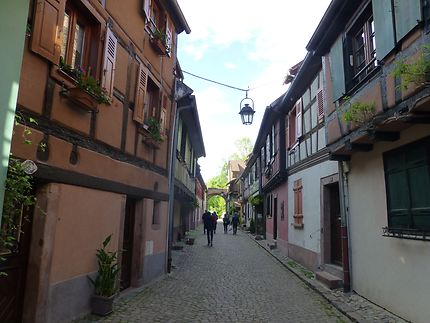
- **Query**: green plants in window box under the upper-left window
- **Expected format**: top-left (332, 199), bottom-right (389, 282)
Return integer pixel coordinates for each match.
top-left (60, 57), bottom-right (111, 104)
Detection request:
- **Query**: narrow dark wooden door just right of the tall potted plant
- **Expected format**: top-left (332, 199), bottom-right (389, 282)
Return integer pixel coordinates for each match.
top-left (120, 198), bottom-right (136, 290)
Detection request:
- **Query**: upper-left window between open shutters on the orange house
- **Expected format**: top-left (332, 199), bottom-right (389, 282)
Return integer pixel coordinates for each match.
top-left (60, 1), bottom-right (100, 77)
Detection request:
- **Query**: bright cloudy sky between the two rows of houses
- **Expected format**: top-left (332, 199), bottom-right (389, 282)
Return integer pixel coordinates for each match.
top-left (178, 0), bottom-right (330, 181)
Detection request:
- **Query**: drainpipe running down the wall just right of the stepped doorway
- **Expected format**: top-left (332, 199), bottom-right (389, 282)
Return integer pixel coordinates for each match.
top-left (338, 162), bottom-right (351, 293)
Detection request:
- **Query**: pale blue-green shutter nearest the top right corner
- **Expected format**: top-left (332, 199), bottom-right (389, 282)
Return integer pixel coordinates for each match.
top-left (394, 0), bottom-right (422, 41)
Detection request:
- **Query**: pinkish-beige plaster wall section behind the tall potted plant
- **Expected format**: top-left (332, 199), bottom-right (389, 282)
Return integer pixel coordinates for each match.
top-left (50, 184), bottom-right (125, 284)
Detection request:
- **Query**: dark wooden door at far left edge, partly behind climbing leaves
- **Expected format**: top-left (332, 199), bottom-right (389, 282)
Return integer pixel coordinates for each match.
top-left (0, 207), bottom-right (34, 323)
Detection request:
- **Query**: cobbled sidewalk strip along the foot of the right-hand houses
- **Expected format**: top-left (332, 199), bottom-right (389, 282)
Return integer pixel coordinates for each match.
top-left (249, 234), bottom-right (408, 323)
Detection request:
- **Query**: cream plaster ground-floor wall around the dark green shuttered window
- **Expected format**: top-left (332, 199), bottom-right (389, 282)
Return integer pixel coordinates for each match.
top-left (349, 126), bottom-right (430, 322)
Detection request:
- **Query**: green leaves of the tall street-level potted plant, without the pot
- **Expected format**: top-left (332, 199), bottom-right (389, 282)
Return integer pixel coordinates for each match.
top-left (88, 235), bottom-right (119, 297)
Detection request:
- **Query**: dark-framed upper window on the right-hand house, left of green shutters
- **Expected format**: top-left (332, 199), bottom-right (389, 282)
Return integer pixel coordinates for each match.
top-left (346, 6), bottom-right (377, 88)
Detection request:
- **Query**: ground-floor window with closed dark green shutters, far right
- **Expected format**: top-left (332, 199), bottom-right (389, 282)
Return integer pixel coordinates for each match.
top-left (384, 137), bottom-right (430, 232)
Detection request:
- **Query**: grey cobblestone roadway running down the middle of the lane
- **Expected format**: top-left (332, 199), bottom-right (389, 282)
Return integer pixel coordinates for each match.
top-left (75, 225), bottom-right (351, 323)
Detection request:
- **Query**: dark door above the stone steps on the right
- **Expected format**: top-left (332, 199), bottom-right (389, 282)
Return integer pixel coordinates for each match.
top-left (329, 183), bottom-right (342, 266)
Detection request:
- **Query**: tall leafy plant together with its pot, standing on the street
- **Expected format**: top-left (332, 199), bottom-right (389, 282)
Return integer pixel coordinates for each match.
top-left (88, 235), bottom-right (119, 316)
